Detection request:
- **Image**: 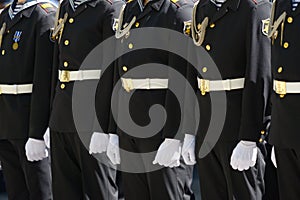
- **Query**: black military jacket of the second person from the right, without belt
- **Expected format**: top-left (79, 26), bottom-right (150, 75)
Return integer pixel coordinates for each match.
top-left (194, 0), bottom-right (271, 142)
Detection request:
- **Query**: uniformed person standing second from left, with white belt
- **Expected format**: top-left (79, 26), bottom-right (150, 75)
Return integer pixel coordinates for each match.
top-left (49, 0), bottom-right (120, 200)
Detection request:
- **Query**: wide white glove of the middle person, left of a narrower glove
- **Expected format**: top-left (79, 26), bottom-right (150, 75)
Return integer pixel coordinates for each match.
top-left (153, 139), bottom-right (181, 168)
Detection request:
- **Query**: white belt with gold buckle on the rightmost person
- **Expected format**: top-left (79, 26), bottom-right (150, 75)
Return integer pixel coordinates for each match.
top-left (273, 80), bottom-right (300, 95)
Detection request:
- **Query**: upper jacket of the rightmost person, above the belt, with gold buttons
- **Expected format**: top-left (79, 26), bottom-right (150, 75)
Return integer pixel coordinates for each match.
top-left (272, 5), bottom-right (300, 81)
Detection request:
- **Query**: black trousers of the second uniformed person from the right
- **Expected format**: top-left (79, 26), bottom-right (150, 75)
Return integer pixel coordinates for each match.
top-left (197, 142), bottom-right (265, 200)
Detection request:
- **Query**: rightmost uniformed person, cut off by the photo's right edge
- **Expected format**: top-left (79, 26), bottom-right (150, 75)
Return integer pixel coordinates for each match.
top-left (269, 0), bottom-right (300, 200)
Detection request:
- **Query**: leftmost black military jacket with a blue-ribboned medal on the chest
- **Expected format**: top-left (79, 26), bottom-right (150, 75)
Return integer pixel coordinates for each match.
top-left (0, 1), bottom-right (56, 139)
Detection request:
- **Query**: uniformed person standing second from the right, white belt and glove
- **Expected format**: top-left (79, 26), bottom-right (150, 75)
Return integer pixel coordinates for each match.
top-left (192, 0), bottom-right (271, 200)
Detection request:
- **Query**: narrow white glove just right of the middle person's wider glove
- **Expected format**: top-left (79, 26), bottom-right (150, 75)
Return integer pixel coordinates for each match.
top-left (181, 134), bottom-right (196, 165)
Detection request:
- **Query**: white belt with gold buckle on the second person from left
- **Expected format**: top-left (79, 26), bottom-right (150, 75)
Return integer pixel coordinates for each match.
top-left (58, 70), bottom-right (101, 82)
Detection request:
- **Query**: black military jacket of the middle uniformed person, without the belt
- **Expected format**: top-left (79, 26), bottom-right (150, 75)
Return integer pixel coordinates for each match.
top-left (110, 0), bottom-right (193, 139)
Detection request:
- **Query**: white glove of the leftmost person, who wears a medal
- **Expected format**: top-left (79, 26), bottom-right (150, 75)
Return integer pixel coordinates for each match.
top-left (25, 138), bottom-right (48, 162)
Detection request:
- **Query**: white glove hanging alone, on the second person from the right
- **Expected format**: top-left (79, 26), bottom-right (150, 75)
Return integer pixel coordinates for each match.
top-left (230, 140), bottom-right (258, 171)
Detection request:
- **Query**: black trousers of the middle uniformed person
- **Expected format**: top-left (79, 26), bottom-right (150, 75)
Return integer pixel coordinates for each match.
top-left (120, 136), bottom-right (194, 200)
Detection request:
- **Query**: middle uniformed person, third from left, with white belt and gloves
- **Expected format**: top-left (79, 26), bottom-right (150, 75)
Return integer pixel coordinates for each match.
top-left (98, 0), bottom-right (195, 200)
